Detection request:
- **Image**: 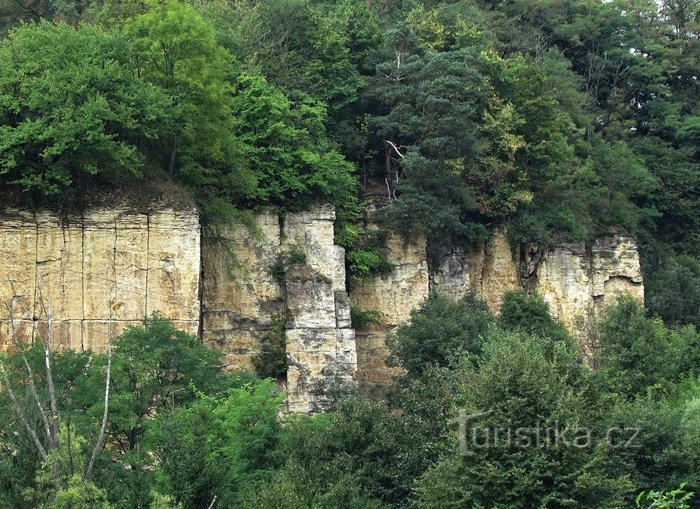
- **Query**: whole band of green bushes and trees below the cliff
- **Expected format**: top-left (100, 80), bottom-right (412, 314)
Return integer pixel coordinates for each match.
top-left (5, 292), bottom-right (700, 509)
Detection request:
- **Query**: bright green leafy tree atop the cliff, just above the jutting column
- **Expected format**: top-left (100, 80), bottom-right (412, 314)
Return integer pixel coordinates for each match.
top-left (232, 74), bottom-right (355, 210)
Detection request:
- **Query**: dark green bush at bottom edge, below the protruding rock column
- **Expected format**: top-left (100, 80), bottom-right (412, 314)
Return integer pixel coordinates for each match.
top-left (243, 397), bottom-right (420, 509)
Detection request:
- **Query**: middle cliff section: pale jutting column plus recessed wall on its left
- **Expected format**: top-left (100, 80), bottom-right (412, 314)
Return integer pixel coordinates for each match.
top-left (202, 207), bottom-right (357, 412)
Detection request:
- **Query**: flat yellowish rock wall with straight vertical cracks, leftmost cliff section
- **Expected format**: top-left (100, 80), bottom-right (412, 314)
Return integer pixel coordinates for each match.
top-left (0, 207), bottom-right (200, 351)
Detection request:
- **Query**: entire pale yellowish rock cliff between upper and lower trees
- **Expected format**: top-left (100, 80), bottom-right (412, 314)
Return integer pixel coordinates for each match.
top-left (0, 200), bottom-right (644, 406)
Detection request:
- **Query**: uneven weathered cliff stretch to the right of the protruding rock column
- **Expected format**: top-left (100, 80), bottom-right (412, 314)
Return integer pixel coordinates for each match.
top-left (350, 229), bottom-right (644, 391)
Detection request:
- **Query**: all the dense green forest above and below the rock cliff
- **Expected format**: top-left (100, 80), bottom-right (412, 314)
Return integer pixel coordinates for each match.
top-left (0, 0), bottom-right (700, 509)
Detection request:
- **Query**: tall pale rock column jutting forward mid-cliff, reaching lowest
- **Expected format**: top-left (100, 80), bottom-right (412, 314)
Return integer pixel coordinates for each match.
top-left (281, 206), bottom-right (357, 412)
